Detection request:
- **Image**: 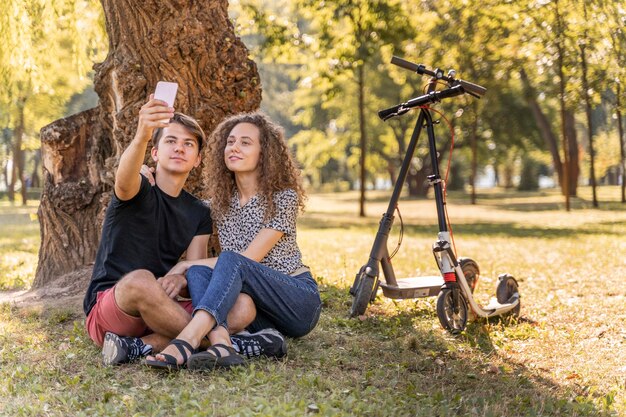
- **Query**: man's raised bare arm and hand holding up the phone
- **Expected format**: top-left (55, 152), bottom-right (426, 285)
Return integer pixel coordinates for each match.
top-left (115, 94), bottom-right (174, 200)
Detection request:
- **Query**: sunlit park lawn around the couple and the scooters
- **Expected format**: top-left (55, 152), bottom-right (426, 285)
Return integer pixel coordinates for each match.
top-left (0, 187), bottom-right (626, 416)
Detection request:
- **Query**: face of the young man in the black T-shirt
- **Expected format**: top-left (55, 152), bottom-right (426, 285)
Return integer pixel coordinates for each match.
top-left (151, 123), bottom-right (200, 174)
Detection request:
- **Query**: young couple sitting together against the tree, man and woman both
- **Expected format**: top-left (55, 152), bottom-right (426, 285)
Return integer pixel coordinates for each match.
top-left (84, 96), bottom-right (321, 370)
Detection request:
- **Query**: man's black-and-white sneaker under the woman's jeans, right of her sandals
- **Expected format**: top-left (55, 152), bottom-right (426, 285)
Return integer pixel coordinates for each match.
top-left (230, 329), bottom-right (287, 358)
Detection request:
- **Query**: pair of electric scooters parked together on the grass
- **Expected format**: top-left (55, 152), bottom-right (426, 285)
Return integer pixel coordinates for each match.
top-left (350, 56), bottom-right (521, 334)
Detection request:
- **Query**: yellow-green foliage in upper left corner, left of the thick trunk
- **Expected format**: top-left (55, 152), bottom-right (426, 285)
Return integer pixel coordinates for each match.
top-left (0, 0), bottom-right (106, 202)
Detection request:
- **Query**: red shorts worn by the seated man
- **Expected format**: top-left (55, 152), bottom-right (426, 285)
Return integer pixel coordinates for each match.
top-left (85, 287), bottom-right (193, 346)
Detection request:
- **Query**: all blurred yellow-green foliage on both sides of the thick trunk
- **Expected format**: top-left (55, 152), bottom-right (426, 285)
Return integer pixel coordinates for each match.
top-left (0, 0), bottom-right (626, 208)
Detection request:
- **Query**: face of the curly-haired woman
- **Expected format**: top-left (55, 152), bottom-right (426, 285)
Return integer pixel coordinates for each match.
top-left (224, 123), bottom-right (261, 174)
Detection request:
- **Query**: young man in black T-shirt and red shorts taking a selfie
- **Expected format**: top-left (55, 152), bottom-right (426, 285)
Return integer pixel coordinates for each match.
top-left (83, 96), bottom-right (268, 365)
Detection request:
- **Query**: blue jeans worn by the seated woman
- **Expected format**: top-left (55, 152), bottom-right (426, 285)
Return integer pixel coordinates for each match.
top-left (187, 251), bottom-right (322, 337)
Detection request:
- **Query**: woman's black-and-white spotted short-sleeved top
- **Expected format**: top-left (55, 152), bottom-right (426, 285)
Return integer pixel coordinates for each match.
top-left (216, 189), bottom-right (303, 274)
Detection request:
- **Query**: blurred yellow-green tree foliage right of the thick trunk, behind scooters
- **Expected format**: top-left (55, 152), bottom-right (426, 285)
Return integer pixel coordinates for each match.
top-left (233, 0), bottom-right (626, 208)
